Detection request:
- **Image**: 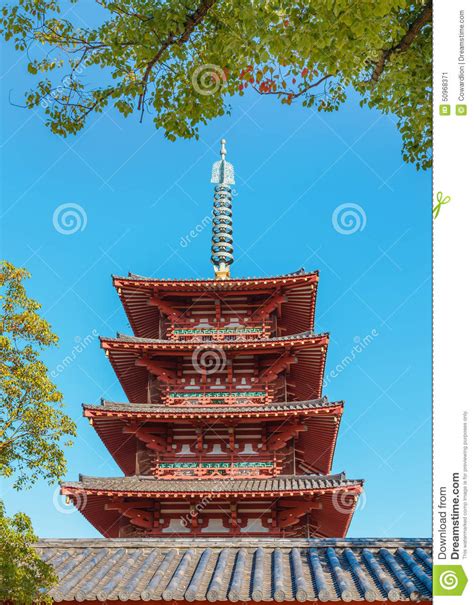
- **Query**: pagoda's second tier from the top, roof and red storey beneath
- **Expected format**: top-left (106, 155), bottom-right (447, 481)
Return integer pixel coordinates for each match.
top-left (101, 332), bottom-right (329, 404)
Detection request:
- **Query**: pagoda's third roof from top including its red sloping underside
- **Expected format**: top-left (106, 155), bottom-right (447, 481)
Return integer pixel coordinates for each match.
top-left (83, 397), bottom-right (344, 475)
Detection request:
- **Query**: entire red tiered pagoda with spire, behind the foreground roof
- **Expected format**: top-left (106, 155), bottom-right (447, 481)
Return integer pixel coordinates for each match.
top-left (62, 141), bottom-right (363, 537)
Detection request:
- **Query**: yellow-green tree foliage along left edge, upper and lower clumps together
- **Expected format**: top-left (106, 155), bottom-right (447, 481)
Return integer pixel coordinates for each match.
top-left (0, 262), bottom-right (75, 602)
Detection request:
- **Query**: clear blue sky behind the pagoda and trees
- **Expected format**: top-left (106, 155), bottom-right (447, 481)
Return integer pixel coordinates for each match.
top-left (0, 39), bottom-right (431, 537)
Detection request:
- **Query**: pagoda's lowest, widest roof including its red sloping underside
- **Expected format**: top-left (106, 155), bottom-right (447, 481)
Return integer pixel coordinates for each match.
top-left (61, 473), bottom-right (364, 537)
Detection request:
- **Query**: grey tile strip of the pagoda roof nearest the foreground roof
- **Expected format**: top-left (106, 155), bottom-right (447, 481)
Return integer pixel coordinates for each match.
top-left (62, 473), bottom-right (364, 494)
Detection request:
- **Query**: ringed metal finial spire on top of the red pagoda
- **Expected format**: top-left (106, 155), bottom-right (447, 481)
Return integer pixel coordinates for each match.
top-left (211, 139), bottom-right (235, 279)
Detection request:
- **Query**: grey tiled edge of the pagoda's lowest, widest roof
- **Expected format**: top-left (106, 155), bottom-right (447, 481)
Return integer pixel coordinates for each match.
top-left (61, 473), bottom-right (364, 498)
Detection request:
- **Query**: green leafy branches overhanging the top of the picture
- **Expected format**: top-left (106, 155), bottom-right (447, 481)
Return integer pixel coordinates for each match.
top-left (0, 0), bottom-right (432, 168)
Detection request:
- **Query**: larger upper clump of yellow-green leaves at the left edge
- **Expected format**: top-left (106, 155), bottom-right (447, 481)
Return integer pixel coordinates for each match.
top-left (0, 263), bottom-right (75, 489)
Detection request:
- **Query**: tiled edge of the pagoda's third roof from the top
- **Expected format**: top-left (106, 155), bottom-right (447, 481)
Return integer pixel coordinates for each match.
top-left (82, 397), bottom-right (344, 420)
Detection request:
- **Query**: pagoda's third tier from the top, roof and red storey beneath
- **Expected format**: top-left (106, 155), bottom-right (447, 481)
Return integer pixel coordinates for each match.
top-left (84, 398), bottom-right (343, 475)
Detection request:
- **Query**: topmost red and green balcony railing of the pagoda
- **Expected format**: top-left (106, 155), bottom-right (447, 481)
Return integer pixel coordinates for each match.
top-left (166, 320), bottom-right (273, 342)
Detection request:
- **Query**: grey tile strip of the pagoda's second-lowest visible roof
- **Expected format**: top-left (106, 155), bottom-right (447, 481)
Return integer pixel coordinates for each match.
top-left (83, 397), bottom-right (344, 414)
